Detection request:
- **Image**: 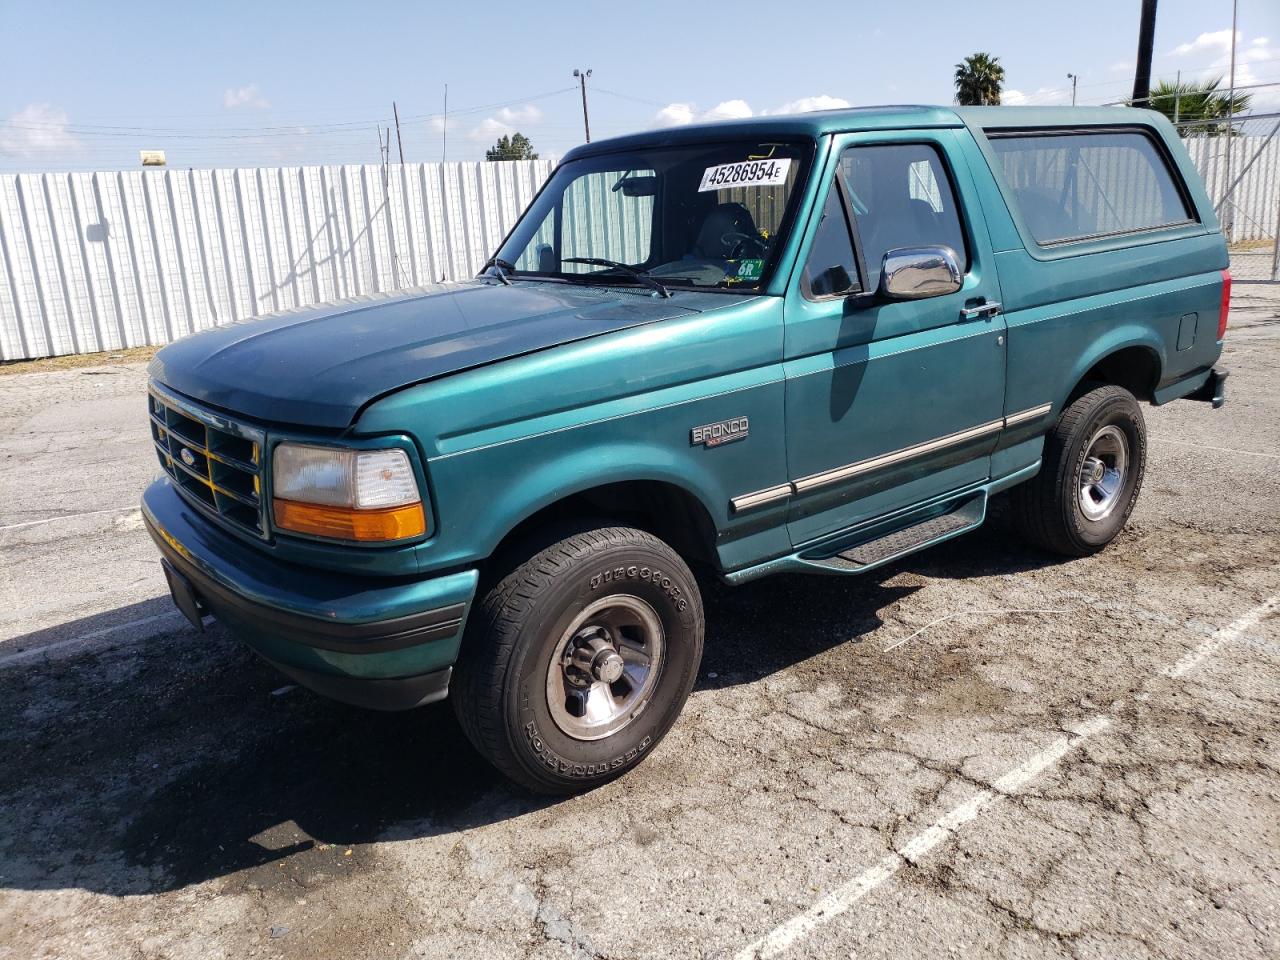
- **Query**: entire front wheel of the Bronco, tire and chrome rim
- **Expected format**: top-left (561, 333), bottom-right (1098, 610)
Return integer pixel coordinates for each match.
top-left (453, 526), bottom-right (703, 794)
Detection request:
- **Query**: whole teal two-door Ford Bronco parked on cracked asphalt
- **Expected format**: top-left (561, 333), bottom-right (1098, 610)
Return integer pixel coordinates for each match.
top-left (142, 106), bottom-right (1230, 792)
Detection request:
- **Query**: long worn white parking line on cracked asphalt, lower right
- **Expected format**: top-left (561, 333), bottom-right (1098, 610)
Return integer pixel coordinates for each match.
top-left (735, 596), bottom-right (1280, 960)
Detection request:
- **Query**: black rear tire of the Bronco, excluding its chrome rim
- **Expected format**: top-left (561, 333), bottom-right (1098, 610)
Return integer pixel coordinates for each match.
top-left (1010, 385), bottom-right (1147, 557)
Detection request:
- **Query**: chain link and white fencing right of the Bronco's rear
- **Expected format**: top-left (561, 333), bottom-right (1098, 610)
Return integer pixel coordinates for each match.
top-left (1178, 113), bottom-right (1280, 282)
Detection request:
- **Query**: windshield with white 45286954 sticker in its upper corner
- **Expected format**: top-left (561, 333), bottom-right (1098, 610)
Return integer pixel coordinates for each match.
top-left (488, 141), bottom-right (813, 292)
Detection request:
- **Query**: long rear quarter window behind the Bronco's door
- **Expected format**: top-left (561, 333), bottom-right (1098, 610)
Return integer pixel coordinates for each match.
top-left (986, 129), bottom-right (1196, 246)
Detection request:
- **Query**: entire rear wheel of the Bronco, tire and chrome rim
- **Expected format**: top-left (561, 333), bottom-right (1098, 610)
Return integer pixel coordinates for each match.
top-left (1011, 385), bottom-right (1147, 557)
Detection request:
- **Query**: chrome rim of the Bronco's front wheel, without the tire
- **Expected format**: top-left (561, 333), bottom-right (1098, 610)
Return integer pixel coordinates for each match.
top-left (547, 594), bottom-right (666, 740)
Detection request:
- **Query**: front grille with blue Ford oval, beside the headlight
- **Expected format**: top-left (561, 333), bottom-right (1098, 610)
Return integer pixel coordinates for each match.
top-left (147, 384), bottom-right (266, 539)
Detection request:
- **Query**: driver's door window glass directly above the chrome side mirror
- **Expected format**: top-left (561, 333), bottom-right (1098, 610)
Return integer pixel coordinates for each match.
top-left (840, 143), bottom-right (969, 275)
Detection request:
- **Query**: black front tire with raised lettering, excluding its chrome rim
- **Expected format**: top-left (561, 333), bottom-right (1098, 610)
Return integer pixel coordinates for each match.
top-left (451, 525), bottom-right (704, 794)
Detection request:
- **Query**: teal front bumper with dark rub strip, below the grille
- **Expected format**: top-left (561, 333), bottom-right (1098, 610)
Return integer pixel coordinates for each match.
top-left (142, 477), bottom-right (479, 709)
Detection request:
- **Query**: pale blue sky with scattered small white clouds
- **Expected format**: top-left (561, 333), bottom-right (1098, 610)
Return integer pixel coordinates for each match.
top-left (0, 0), bottom-right (1280, 173)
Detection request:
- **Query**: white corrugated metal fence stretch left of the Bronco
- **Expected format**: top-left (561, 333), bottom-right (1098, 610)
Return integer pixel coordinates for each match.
top-left (0, 160), bottom-right (553, 360)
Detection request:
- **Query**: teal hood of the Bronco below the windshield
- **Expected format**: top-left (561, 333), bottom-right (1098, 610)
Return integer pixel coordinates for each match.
top-left (150, 280), bottom-right (726, 429)
